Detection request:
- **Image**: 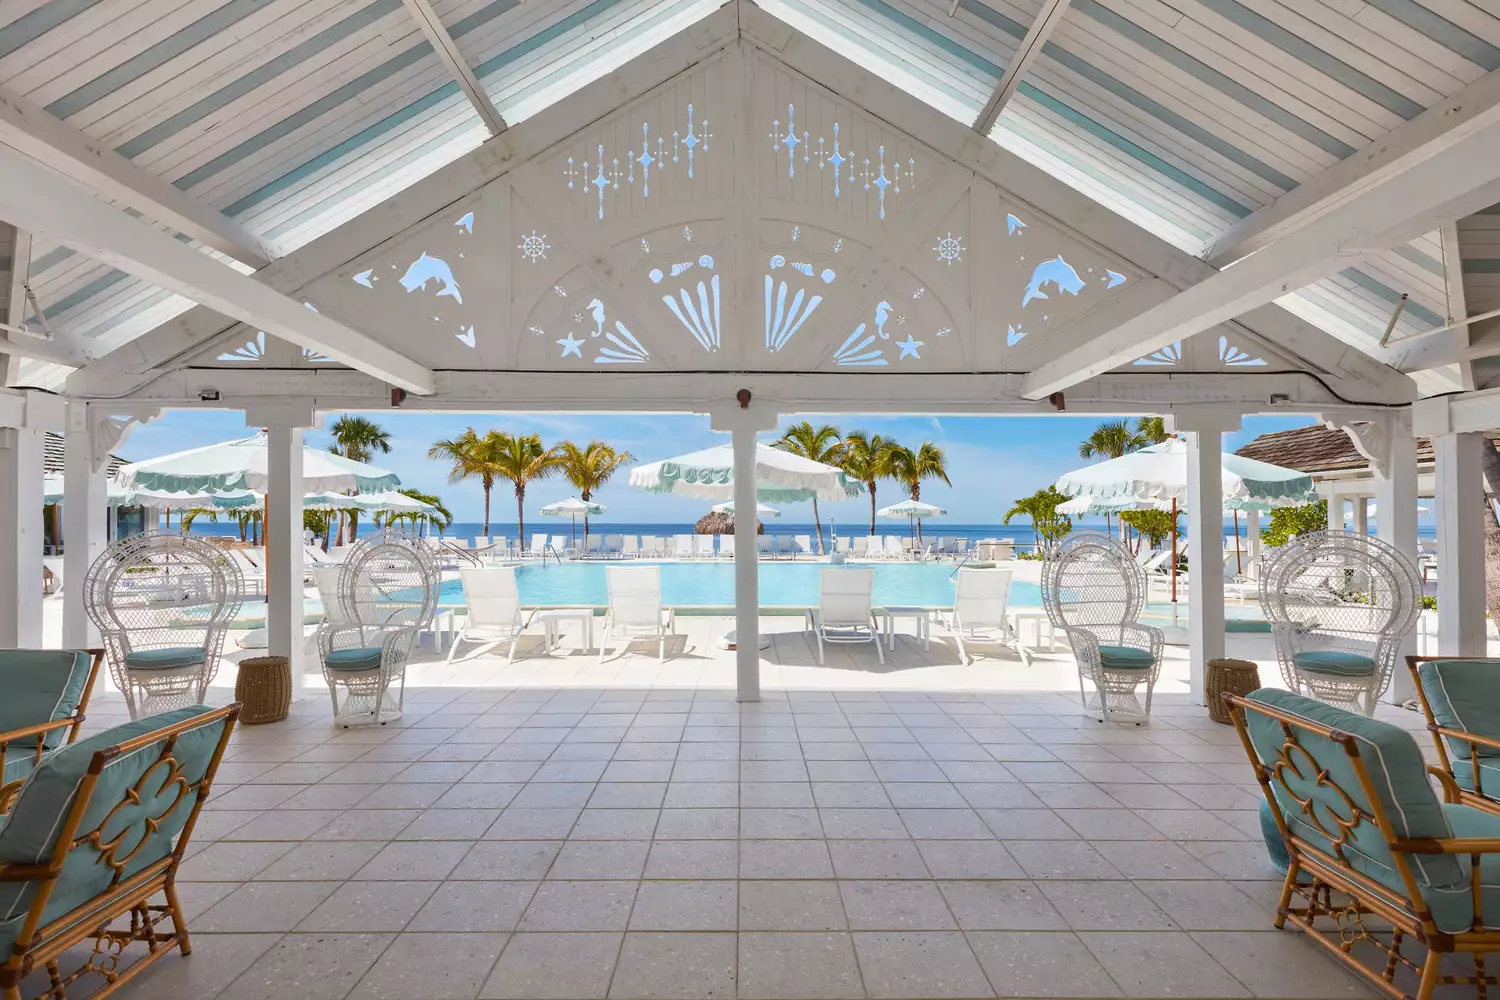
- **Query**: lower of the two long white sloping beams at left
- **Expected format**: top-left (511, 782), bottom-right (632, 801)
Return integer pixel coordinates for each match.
top-left (0, 147), bottom-right (432, 393)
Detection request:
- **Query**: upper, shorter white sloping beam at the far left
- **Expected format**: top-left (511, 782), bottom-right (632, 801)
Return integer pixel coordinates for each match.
top-left (0, 90), bottom-right (272, 270)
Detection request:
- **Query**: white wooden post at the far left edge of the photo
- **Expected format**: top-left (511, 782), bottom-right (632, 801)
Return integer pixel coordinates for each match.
top-left (0, 390), bottom-right (63, 649)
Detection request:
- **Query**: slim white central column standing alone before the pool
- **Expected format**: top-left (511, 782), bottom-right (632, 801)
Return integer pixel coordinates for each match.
top-left (711, 390), bottom-right (776, 702)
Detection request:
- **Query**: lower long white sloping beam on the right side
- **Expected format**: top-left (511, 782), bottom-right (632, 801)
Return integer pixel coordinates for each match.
top-left (1026, 112), bottom-right (1500, 399)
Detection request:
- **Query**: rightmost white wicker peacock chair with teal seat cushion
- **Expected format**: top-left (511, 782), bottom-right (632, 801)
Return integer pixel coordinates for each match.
top-left (1260, 531), bottom-right (1422, 715)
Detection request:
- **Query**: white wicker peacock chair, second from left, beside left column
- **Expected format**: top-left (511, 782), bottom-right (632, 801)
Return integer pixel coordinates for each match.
top-left (317, 532), bottom-right (441, 727)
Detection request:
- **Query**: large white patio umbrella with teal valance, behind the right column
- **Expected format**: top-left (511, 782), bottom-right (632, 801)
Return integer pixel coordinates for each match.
top-left (1056, 438), bottom-right (1313, 603)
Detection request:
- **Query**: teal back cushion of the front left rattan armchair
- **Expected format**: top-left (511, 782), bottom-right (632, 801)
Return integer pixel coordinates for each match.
top-left (0, 705), bottom-right (227, 954)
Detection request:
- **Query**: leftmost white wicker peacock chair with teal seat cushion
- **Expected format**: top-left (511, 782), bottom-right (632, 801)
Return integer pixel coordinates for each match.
top-left (84, 531), bottom-right (245, 718)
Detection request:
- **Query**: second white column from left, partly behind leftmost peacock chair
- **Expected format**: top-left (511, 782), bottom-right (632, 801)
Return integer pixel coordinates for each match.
top-left (63, 402), bottom-right (110, 649)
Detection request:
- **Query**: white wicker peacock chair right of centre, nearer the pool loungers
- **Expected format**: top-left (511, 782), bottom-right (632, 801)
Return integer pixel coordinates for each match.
top-left (1041, 531), bottom-right (1164, 726)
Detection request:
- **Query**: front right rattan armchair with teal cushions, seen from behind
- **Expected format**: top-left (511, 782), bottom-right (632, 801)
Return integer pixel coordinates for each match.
top-left (1227, 688), bottom-right (1500, 1000)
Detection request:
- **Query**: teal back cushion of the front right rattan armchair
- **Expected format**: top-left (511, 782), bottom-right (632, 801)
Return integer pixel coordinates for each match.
top-left (1245, 688), bottom-right (1469, 931)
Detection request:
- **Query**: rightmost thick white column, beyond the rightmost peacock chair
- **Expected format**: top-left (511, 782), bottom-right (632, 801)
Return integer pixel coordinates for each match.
top-left (1433, 432), bottom-right (1485, 657)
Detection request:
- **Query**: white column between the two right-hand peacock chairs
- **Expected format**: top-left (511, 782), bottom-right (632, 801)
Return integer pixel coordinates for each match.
top-left (1175, 411), bottom-right (1239, 705)
